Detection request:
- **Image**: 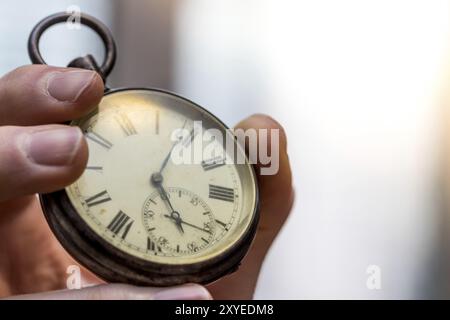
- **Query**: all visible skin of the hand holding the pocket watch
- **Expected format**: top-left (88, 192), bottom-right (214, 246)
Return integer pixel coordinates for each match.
top-left (0, 65), bottom-right (294, 299)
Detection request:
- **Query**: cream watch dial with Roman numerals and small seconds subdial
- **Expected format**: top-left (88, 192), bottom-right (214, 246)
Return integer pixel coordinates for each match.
top-left (66, 90), bottom-right (257, 265)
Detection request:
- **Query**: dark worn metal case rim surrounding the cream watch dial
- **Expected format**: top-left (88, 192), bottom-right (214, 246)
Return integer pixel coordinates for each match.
top-left (39, 87), bottom-right (260, 286)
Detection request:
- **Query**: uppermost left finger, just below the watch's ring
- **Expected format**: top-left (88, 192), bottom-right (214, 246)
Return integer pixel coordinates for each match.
top-left (0, 65), bottom-right (104, 126)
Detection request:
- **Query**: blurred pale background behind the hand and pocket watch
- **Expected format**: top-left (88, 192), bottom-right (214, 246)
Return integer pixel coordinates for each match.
top-left (0, 0), bottom-right (450, 299)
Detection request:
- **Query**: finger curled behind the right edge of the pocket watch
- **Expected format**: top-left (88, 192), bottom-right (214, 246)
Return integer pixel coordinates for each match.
top-left (207, 114), bottom-right (294, 299)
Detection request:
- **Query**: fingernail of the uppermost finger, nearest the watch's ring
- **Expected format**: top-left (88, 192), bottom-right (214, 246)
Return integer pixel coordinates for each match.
top-left (47, 71), bottom-right (95, 102)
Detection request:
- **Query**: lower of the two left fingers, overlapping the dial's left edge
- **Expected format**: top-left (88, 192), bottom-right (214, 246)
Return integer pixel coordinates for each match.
top-left (0, 125), bottom-right (88, 201)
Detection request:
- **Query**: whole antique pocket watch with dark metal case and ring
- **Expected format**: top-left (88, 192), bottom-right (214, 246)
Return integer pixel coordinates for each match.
top-left (28, 13), bottom-right (259, 286)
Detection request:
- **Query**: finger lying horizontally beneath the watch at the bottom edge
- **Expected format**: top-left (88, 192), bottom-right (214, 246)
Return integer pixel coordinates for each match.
top-left (7, 284), bottom-right (212, 300)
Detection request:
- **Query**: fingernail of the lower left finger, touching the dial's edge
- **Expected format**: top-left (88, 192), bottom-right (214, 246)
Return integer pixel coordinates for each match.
top-left (25, 127), bottom-right (82, 166)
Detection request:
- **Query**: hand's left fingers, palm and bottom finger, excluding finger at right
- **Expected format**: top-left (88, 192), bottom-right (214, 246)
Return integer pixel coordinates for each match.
top-left (0, 66), bottom-right (210, 299)
